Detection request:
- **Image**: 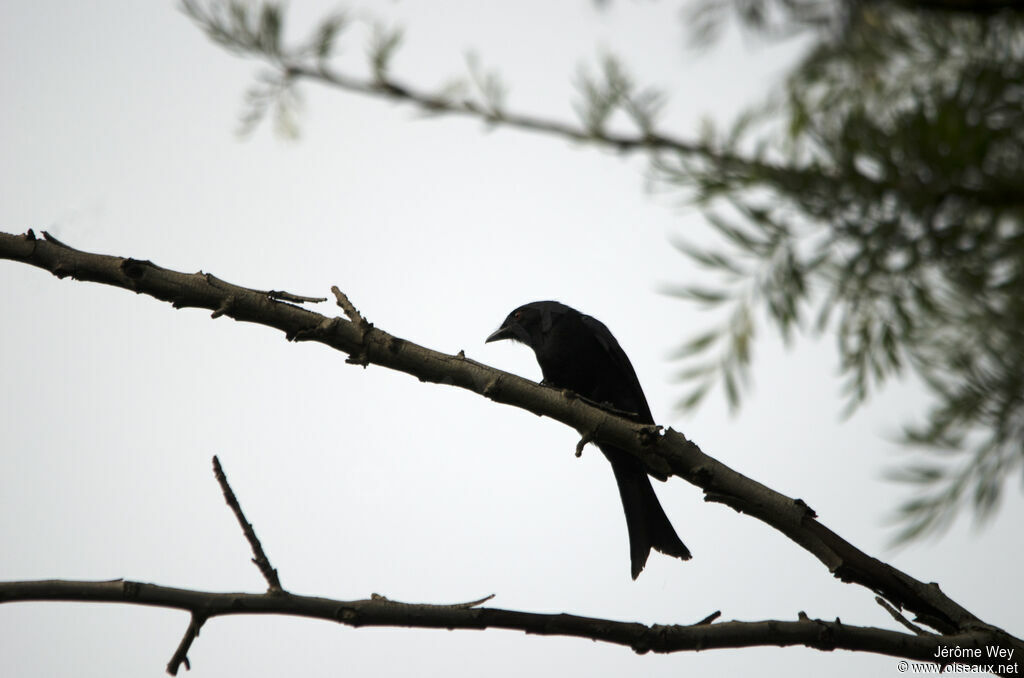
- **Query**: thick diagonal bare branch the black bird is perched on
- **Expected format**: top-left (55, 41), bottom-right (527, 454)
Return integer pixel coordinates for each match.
top-left (0, 231), bottom-right (1024, 656)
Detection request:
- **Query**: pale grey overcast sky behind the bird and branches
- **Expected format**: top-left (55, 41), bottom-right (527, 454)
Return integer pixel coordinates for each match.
top-left (0, 0), bottom-right (1024, 678)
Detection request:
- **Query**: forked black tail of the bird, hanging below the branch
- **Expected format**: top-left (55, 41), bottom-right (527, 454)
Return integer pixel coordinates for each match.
top-left (602, 450), bottom-right (691, 579)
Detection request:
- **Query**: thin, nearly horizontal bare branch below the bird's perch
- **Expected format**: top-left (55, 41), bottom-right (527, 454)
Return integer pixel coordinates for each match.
top-left (0, 580), bottom-right (1007, 673)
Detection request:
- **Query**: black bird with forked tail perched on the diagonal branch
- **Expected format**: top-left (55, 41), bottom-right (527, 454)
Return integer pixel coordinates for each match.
top-left (487, 301), bottom-right (690, 579)
